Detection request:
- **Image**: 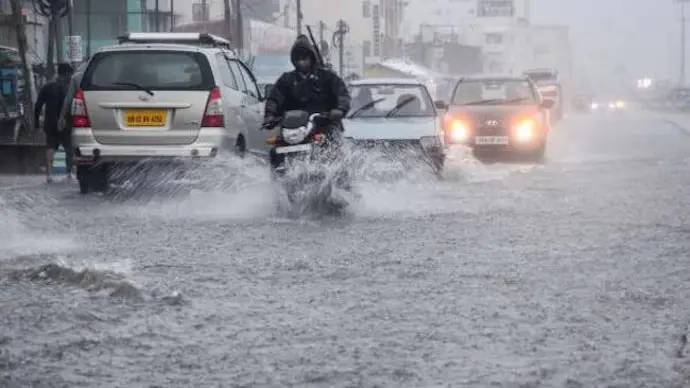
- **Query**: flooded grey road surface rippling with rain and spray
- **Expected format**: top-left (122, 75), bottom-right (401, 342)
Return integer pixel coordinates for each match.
top-left (0, 110), bottom-right (690, 388)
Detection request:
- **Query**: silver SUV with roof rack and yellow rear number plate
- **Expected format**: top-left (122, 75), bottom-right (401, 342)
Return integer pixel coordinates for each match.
top-left (71, 33), bottom-right (263, 193)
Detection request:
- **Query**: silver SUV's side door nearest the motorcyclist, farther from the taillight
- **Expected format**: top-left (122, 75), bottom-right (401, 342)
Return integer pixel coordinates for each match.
top-left (230, 59), bottom-right (272, 154)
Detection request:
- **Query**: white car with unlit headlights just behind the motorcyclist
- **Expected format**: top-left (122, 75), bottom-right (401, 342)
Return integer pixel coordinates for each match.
top-left (343, 78), bottom-right (446, 174)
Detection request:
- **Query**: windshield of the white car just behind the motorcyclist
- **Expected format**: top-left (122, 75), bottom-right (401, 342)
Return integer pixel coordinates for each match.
top-left (350, 84), bottom-right (436, 117)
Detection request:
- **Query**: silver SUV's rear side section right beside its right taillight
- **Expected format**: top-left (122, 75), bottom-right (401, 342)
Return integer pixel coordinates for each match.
top-left (215, 53), bottom-right (247, 149)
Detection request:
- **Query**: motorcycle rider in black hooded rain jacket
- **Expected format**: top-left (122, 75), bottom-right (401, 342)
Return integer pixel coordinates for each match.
top-left (263, 35), bottom-right (351, 139)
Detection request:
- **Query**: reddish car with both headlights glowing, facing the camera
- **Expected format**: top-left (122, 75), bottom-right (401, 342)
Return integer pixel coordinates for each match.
top-left (445, 75), bottom-right (553, 162)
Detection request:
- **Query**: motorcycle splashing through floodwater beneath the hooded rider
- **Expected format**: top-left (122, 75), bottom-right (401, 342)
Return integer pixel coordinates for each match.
top-left (265, 110), bottom-right (349, 213)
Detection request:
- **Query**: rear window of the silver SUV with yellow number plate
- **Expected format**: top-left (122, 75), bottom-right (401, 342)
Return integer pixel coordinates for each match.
top-left (81, 50), bottom-right (215, 90)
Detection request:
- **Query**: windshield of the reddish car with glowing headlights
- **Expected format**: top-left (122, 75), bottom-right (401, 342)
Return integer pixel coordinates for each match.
top-left (451, 79), bottom-right (537, 105)
